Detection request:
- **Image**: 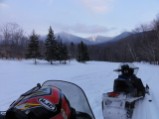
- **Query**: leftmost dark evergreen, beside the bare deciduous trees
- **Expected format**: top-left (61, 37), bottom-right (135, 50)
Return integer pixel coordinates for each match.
top-left (26, 31), bottom-right (40, 64)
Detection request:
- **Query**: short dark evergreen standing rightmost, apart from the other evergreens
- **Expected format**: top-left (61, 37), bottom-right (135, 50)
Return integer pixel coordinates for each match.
top-left (77, 42), bottom-right (89, 62)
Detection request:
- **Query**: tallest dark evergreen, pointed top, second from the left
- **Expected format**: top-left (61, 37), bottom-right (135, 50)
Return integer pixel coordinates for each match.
top-left (45, 26), bottom-right (57, 64)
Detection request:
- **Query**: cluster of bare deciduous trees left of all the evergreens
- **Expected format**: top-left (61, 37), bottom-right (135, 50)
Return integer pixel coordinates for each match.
top-left (0, 23), bottom-right (26, 58)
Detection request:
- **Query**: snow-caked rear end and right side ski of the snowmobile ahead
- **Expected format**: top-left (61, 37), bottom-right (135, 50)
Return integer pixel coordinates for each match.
top-left (102, 85), bottom-right (152, 119)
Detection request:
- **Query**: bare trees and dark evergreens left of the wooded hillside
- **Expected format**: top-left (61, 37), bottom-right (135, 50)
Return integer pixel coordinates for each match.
top-left (0, 23), bottom-right (89, 64)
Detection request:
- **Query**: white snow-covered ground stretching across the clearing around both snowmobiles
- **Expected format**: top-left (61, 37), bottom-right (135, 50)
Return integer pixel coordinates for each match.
top-left (0, 60), bottom-right (159, 119)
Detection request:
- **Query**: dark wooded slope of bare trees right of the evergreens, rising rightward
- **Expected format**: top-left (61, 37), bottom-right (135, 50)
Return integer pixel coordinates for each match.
top-left (89, 18), bottom-right (159, 64)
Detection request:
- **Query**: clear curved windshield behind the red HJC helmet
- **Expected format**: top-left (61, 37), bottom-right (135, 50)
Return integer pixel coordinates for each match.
top-left (42, 80), bottom-right (95, 119)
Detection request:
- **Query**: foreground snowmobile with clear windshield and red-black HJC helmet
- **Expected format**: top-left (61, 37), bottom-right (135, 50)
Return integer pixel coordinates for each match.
top-left (0, 80), bottom-right (95, 119)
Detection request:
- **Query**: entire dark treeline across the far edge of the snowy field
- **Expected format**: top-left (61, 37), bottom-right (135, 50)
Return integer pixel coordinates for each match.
top-left (0, 15), bottom-right (159, 64)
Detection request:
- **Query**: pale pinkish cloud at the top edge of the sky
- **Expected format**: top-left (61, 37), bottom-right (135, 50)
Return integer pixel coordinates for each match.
top-left (81, 0), bottom-right (114, 13)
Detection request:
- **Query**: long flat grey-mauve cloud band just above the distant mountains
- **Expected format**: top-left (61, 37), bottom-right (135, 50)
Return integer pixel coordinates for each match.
top-left (56, 24), bottom-right (114, 34)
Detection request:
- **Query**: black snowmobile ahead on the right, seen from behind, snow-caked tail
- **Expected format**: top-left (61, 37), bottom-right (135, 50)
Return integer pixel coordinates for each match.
top-left (102, 64), bottom-right (151, 119)
